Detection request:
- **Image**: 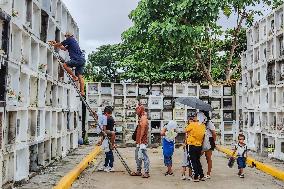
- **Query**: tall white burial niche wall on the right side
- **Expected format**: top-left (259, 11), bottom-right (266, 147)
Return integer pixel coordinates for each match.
top-left (239, 5), bottom-right (284, 160)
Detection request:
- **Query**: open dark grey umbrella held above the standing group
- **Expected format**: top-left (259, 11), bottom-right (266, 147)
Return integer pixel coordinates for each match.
top-left (175, 97), bottom-right (213, 111)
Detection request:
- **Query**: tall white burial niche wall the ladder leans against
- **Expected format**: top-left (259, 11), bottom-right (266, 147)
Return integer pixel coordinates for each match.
top-left (0, 0), bottom-right (81, 185)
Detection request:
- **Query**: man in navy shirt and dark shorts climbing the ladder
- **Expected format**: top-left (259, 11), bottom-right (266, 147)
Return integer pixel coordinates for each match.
top-left (49, 32), bottom-right (86, 96)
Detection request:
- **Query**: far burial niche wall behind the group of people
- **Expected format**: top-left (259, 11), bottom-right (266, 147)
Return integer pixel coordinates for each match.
top-left (86, 82), bottom-right (236, 144)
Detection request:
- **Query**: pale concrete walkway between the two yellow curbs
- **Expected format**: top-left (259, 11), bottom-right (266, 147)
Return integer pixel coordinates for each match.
top-left (72, 148), bottom-right (284, 189)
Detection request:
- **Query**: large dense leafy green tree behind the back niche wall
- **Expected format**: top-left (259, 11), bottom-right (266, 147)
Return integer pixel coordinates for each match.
top-left (120, 0), bottom-right (222, 82)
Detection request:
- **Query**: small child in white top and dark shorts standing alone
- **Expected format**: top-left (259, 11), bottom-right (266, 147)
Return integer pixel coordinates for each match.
top-left (232, 134), bottom-right (247, 178)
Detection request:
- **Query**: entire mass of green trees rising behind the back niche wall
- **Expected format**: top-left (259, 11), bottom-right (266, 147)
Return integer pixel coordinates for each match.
top-left (86, 0), bottom-right (282, 83)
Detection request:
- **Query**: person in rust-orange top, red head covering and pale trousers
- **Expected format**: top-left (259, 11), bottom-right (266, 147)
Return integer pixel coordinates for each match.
top-left (131, 104), bottom-right (150, 178)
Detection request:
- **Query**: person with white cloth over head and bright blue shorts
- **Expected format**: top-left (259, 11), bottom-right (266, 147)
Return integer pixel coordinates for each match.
top-left (161, 120), bottom-right (177, 176)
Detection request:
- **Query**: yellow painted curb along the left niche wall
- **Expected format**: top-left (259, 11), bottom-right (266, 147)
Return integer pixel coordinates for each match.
top-left (53, 146), bottom-right (102, 189)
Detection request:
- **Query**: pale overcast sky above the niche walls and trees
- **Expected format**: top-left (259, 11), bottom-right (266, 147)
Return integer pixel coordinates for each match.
top-left (63, 0), bottom-right (269, 53)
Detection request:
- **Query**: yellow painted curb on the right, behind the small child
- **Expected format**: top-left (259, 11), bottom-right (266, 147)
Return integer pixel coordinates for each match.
top-left (216, 146), bottom-right (284, 180)
